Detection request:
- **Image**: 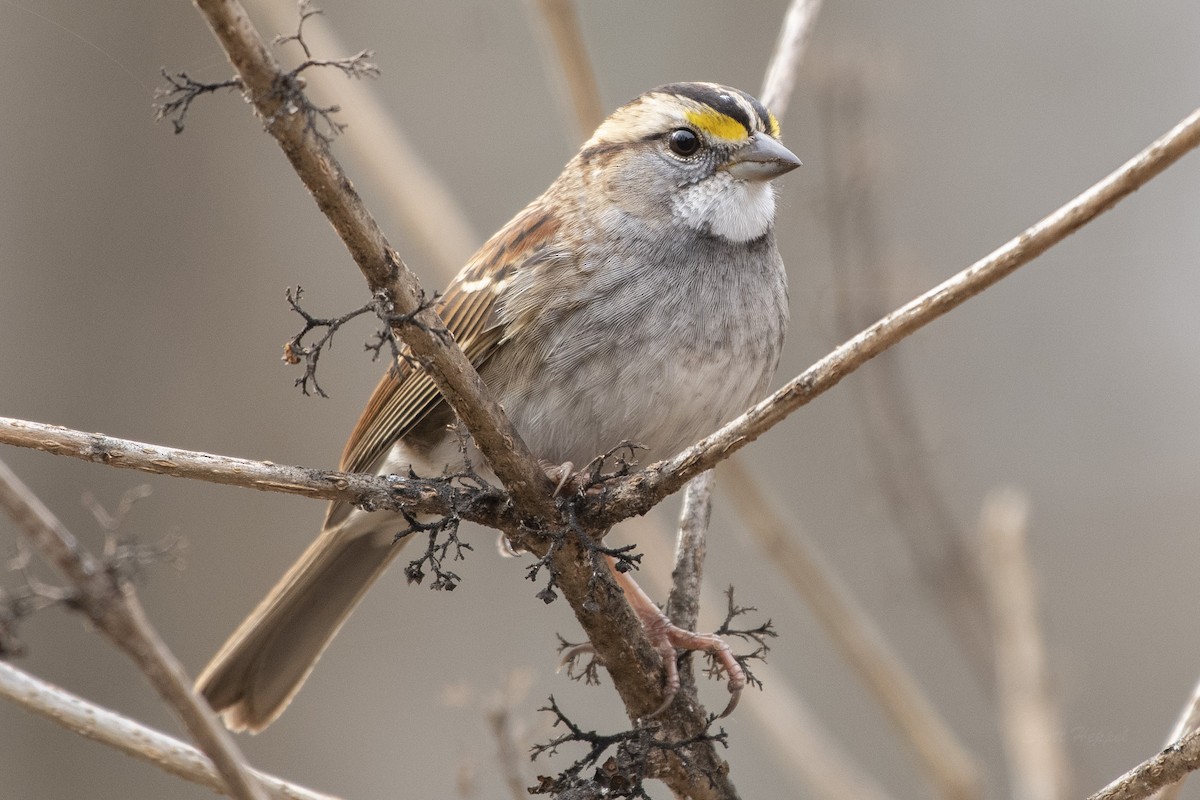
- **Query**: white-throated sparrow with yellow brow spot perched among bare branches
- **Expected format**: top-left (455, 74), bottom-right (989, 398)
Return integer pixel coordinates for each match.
top-left (197, 83), bottom-right (799, 730)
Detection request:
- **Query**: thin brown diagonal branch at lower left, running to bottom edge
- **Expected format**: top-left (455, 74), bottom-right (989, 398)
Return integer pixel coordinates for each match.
top-left (0, 462), bottom-right (265, 800)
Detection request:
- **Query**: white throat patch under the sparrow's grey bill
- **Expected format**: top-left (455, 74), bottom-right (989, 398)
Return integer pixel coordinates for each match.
top-left (672, 172), bottom-right (775, 242)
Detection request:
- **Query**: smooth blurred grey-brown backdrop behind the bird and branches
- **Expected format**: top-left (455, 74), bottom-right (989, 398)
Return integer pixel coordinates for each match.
top-left (0, 0), bottom-right (1200, 799)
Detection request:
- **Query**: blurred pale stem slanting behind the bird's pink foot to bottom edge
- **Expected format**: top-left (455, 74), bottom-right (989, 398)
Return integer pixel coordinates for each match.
top-left (623, 517), bottom-right (889, 800)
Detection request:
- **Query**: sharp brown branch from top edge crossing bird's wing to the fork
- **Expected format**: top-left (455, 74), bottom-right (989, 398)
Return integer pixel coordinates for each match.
top-left (196, 0), bottom-right (554, 518)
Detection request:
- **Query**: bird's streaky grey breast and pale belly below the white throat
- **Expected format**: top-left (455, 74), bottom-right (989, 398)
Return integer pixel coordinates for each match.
top-left (484, 235), bottom-right (787, 467)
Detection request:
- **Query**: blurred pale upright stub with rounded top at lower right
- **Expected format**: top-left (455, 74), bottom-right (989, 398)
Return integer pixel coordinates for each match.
top-left (979, 489), bottom-right (1070, 800)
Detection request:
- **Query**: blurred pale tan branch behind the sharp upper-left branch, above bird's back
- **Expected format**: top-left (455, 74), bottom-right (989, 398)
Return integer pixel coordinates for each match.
top-left (253, 0), bottom-right (481, 281)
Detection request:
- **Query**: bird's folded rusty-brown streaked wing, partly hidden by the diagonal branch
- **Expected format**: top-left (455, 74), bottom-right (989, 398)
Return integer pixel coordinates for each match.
top-left (326, 203), bottom-right (558, 491)
